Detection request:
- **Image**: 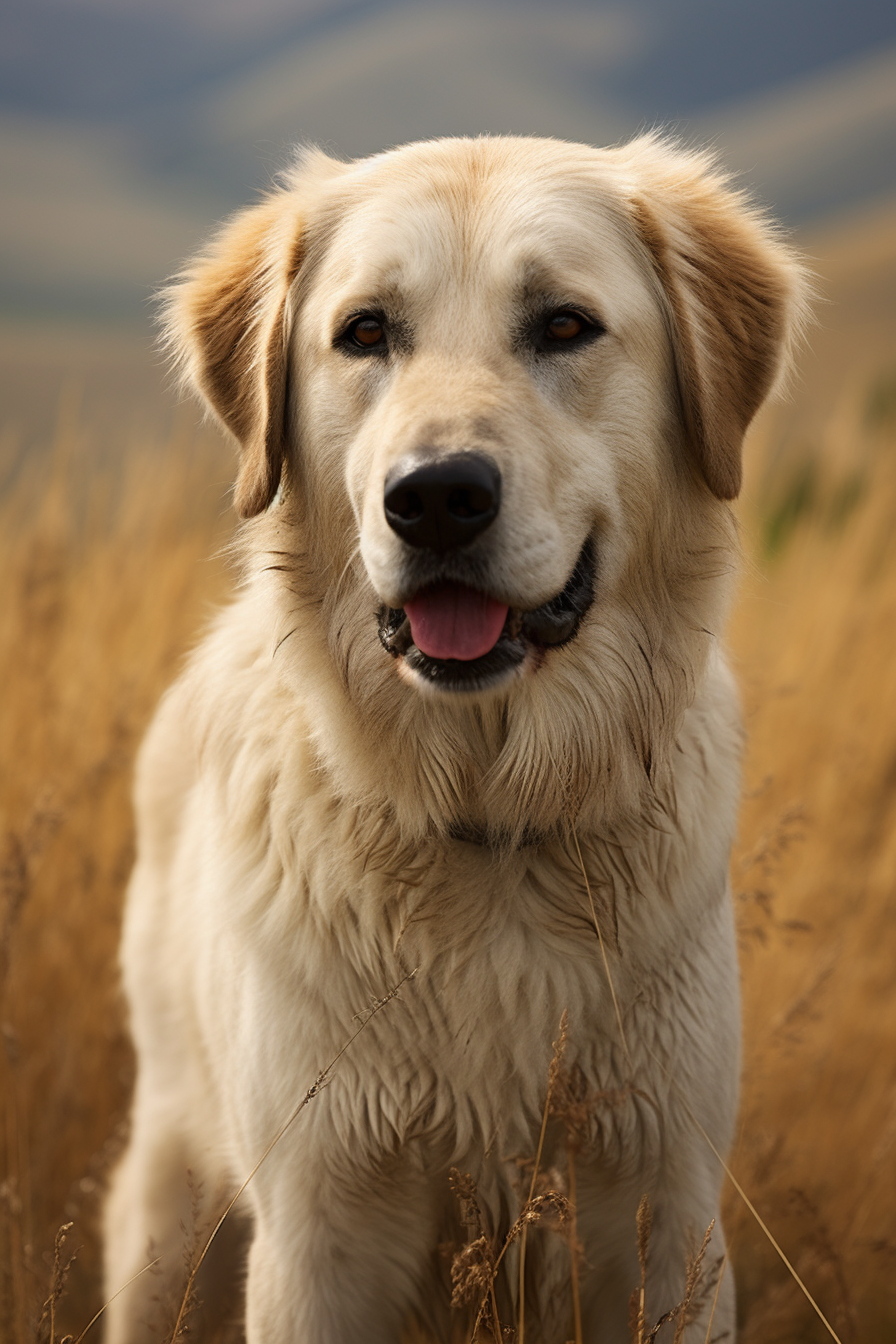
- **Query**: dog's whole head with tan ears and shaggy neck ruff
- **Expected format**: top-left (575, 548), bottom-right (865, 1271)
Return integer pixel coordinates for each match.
top-left (168, 137), bottom-right (801, 832)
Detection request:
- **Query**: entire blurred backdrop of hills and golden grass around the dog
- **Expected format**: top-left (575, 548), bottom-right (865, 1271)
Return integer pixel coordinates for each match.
top-left (0, 0), bottom-right (896, 1344)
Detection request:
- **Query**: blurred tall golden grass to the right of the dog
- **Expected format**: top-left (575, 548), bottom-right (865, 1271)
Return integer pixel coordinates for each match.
top-left (728, 382), bottom-right (896, 1344)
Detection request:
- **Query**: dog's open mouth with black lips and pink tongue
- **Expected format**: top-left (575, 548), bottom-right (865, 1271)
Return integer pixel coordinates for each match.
top-left (377, 538), bottom-right (595, 691)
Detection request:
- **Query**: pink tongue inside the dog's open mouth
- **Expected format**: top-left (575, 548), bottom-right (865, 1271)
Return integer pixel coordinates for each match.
top-left (404, 583), bottom-right (508, 663)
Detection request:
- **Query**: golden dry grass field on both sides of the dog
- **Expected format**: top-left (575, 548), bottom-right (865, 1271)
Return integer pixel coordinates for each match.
top-left (0, 201), bottom-right (896, 1344)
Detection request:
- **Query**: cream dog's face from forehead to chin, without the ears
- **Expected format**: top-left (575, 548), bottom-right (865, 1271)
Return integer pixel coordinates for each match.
top-left (290, 144), bottom-right (677, 692)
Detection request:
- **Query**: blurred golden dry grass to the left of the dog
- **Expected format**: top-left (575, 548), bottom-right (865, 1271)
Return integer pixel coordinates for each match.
top-left (0, 395), bottom-right (230, 1344)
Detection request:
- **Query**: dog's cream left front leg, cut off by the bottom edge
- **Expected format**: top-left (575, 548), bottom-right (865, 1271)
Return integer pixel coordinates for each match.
top-left (246, 1136), bottom-right (437, 1344)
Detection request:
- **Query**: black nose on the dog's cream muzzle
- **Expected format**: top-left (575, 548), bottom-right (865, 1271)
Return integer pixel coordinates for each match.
top-left (383, 453), bottom-right (501, 551)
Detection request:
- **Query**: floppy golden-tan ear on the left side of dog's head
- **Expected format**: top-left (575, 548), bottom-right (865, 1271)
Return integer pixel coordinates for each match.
top-left (163, 151), bottom-right (344, 517)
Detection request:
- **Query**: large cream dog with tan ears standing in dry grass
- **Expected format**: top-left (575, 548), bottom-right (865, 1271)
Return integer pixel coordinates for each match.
top-left (106, 136), bottom-right (805, 1344)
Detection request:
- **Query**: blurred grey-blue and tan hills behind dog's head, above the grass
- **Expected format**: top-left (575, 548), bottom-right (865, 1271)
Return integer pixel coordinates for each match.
top-left (0, 0), bottom-right (896, 451)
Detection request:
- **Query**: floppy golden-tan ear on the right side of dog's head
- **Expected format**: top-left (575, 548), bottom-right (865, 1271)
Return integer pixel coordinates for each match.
top-left (622, 136), bottom-right (809, 500)
